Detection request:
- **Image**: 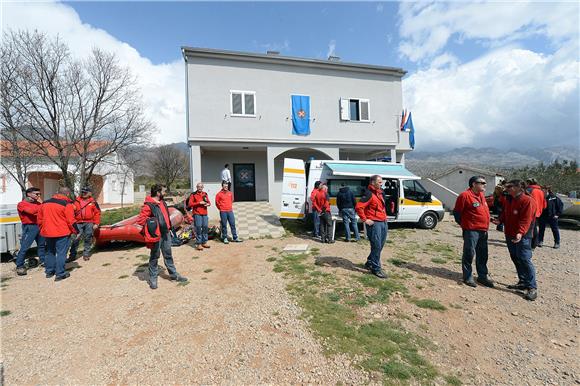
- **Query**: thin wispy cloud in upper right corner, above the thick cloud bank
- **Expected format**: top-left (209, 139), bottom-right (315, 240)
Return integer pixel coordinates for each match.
top-left (399, 1), bottom-right (580, 62)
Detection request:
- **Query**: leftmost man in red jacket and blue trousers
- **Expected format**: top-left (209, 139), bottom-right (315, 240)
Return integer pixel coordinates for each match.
top-left (16, 188), bottom-right (45, 276)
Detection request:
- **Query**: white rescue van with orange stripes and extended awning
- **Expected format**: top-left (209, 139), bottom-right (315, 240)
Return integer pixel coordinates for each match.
top-left (280, 158), bottom-right (445, 229)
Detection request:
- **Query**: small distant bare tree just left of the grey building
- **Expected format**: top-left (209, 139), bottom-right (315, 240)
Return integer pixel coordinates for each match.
top-left (151, 145), bottom-right (188, 191)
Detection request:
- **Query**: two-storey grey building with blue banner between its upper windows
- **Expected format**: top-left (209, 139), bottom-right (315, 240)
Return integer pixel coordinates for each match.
top-left (182, 47), bottom-right (411, 216)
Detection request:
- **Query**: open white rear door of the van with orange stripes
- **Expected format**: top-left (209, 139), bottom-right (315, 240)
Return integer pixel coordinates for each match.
top-left (280, 158), bottom-right (306, 219)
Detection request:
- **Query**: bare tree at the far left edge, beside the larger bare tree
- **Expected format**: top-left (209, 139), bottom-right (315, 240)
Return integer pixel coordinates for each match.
top-left (0, 34), bottom-right (38, 198)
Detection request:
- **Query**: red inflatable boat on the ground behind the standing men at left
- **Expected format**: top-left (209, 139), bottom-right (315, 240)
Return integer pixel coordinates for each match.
top-left (95, 208), bottom-right (183, 247)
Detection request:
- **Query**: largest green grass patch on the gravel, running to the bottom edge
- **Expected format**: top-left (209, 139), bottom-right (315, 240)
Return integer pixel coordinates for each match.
top-left (273, 254), bottom-right (439, 384)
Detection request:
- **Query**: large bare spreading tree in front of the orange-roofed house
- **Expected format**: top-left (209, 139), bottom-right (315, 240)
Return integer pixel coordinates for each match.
top-left (3, 31), bottom-right (153, 195)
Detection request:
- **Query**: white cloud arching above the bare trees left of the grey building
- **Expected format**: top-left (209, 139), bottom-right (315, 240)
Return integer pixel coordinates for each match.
top-left (2, 2), bottom-right (186, 143)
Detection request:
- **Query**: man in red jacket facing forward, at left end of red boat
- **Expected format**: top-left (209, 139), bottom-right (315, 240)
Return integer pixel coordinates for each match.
top-left (68, 187), bottom-right (101, 262)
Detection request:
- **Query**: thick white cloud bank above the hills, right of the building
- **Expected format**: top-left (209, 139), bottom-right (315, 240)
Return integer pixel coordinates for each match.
top-left (403, 47), bottom-right (580, 150)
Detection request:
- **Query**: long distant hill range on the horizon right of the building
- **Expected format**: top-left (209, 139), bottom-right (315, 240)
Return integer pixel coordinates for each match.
top-left (405, 146), bottom-right (580, 177)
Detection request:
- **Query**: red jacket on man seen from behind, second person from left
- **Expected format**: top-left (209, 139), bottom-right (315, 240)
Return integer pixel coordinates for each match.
top-left (38, 194), bottom-right (78, 237)
